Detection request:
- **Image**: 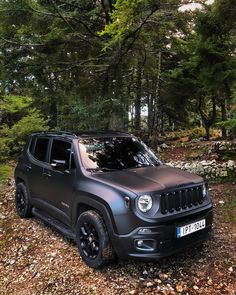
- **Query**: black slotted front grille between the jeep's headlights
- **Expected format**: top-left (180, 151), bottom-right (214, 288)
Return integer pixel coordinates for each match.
top-left (160, 186), bottom-right (203, 214)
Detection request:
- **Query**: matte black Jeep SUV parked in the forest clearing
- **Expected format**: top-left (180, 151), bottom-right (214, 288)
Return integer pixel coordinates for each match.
top-left (15, 131), bottom-right (212, 268)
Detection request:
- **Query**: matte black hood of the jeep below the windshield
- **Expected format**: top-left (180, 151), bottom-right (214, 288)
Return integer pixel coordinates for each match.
top-left (93, 165), bottom-right (203, 194)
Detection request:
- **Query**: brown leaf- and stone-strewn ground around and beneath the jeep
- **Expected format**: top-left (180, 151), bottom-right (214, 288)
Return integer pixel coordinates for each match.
top-left (0, 170), bottom-right (236, 295)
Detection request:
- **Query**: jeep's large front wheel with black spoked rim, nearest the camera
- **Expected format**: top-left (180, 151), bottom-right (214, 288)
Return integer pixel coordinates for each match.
top-left (76, 210), bottom-right (114, 268)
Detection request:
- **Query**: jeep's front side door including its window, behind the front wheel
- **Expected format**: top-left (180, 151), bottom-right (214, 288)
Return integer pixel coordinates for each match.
top-left (43, 138), bottom-right (76, 224)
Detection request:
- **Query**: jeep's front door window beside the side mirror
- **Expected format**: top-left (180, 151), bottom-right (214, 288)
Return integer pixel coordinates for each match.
top-left (50, 139), bottom-right (71, 169)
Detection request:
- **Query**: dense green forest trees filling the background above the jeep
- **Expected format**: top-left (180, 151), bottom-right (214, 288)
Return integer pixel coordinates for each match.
top-left (0, 0), bottom-right (236, 138)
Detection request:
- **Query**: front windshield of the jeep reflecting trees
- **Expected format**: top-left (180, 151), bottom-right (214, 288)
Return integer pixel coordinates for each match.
top-left (79, 137), bottom-right (160, 171)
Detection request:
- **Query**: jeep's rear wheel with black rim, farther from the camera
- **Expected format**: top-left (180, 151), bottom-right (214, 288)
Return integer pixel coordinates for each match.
top-left (15, 182), bottom-right (32, 218)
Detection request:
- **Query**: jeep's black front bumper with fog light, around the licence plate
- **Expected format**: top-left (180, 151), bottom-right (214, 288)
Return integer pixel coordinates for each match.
top-left (113, 208), bottom-right (213, 260)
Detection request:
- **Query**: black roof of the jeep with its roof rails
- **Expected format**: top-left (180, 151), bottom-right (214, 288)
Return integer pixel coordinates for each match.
top-left (32, 130), bottom-right (131, 138)
